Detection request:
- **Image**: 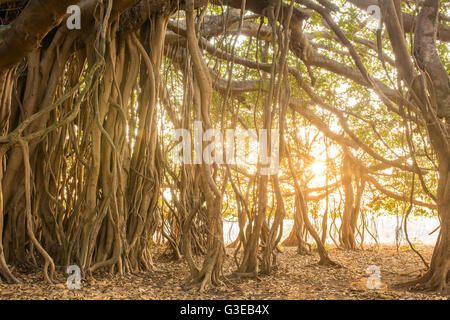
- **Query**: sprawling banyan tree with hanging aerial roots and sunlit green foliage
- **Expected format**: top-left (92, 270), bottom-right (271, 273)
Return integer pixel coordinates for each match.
top-left (0, 0), bottom-right (450, 292)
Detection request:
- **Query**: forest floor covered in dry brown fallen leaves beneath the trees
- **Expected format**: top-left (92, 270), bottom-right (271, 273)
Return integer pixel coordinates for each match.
top-left (0, 246), bottom-right (448, 300)
